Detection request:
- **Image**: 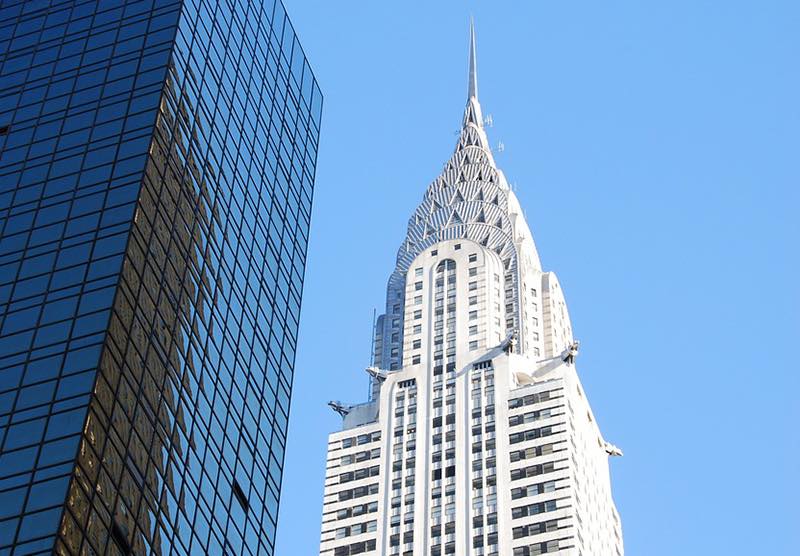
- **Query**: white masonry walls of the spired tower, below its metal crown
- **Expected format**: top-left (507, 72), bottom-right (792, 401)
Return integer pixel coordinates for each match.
top-left (320, 240), bottom-right (623, 556)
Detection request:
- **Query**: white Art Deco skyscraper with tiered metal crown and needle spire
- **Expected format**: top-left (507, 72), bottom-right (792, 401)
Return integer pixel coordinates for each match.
top-left (320, 22), bottom-right (623, 556)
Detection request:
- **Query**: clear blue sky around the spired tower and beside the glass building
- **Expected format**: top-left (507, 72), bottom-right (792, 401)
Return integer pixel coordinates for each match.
top-left (277, 0), bottom-right (800, 556)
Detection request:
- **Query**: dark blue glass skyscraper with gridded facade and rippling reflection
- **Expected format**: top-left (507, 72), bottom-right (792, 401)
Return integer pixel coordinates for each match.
top-left (0, 0), bottom-right (322, 554)
